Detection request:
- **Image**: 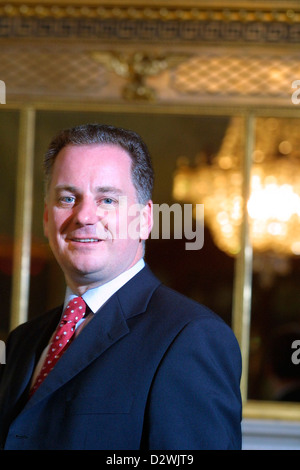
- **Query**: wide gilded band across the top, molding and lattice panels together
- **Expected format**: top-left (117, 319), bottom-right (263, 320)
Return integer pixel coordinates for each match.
top-left (0, 0), bottom-right (300, 105)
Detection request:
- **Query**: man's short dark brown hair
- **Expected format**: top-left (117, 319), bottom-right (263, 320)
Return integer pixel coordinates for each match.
top-left (44, 124), bottom-right (154, 204)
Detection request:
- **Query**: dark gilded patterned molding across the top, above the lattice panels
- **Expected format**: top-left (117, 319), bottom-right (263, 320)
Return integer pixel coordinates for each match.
top-left (0, 0), bottom-right (300, 46)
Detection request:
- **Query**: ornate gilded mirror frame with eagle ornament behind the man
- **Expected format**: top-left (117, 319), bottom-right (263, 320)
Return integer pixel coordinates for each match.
top-left (0, 0), bottom-right (300, 420)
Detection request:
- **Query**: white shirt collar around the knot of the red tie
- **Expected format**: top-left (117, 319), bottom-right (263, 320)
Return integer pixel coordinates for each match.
top-left (64, 259), bottom-right (145, 313)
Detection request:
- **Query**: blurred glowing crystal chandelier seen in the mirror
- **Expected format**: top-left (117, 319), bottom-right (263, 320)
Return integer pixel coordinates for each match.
top-left (173, 117), bottom-right (300, 257)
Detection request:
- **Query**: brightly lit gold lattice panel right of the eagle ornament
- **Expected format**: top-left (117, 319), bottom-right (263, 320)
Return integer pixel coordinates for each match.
top-left (171, 52), bottom-right (300, 98)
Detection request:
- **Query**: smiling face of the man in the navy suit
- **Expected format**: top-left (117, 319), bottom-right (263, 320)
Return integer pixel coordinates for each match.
top-left (44, 144), bottom-right (152, 294)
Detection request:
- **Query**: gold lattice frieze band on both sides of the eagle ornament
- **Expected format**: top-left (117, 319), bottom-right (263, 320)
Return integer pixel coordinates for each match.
top-left (0, 41), bottom-right (300, 105)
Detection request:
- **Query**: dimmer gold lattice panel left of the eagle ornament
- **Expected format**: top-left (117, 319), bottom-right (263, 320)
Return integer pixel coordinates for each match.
top-left (0, 47), bottom-right (107, 99)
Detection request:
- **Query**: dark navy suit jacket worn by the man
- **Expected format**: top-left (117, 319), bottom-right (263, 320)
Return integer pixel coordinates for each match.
top-left (0, 266), bottom-right (241, 450)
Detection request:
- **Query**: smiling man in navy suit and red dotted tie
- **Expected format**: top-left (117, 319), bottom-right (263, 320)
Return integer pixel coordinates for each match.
top-left (0, 125), bottom-right (241, 450)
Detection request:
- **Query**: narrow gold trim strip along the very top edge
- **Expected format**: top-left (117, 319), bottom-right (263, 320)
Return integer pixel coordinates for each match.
top-left (0, 0), bottom-right (300, 23)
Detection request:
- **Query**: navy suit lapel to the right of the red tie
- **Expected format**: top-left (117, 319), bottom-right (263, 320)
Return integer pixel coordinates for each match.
top-left (25, 268), bottom-right (159, 409)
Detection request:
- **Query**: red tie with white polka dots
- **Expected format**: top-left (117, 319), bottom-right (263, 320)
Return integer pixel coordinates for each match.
top-left (30, 297), bottom-right (86, 396)
